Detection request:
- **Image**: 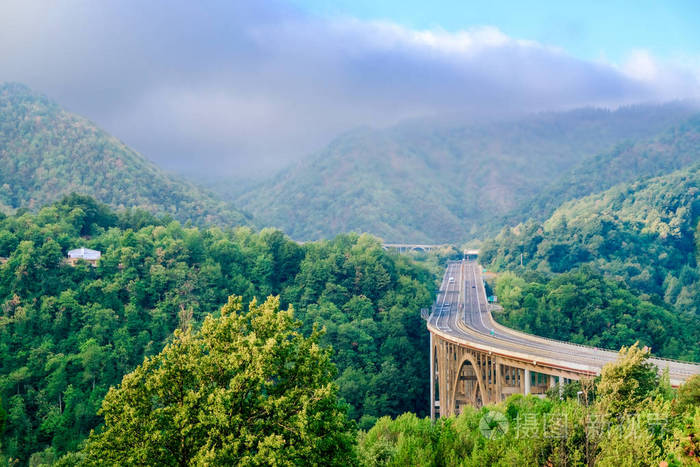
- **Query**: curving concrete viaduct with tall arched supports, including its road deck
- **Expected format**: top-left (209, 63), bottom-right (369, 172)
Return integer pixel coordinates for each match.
top-left (427, 259), bottom-right (700, 418)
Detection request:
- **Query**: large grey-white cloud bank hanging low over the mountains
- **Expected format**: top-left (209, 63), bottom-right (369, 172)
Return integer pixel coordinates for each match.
top-left (0, 0), bottom-right (700, 176)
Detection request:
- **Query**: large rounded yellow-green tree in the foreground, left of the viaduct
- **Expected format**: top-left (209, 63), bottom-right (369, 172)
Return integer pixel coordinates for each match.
top-left (78, 297), bottom-right (354, 465)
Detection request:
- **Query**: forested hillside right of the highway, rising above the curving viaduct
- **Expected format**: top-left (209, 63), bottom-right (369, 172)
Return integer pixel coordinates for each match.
top-left (482, 164), bottom-right (700, 361)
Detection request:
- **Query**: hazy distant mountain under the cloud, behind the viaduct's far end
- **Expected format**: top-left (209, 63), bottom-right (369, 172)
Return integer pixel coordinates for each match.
top-left (236, 104), bottom-right (695, 242)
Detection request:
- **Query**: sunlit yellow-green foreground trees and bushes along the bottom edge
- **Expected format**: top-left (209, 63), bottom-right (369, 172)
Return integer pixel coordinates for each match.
top-left (35, 297), bottom-right (700, 466)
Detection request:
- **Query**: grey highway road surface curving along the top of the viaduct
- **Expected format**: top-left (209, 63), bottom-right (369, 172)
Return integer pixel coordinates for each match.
top-left (428, 260), bottom-right (700, 386)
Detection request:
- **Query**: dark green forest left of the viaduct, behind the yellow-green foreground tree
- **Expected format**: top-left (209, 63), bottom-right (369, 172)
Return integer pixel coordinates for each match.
top-left (0, 195), bottom-right (435, 463)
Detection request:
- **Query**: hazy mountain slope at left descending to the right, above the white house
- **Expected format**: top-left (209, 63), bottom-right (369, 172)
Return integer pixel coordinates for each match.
top-left (0, 84), bottom-right (249, 226)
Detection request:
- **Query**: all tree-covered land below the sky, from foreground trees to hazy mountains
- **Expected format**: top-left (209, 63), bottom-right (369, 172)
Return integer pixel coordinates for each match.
top-left (0, 84), bottom-right (700, 466)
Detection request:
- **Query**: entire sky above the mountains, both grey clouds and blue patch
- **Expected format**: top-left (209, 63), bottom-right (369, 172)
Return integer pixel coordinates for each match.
top-left (0, 0), bottom-right (700, 180)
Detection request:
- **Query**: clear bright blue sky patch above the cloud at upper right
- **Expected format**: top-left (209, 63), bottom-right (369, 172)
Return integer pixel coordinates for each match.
top-left (293, 0), bottom-right (700, 63)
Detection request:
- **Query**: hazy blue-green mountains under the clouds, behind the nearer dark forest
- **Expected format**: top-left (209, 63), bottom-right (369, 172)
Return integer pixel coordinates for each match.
top-left (0, 83), bottom-right (700, 243)
